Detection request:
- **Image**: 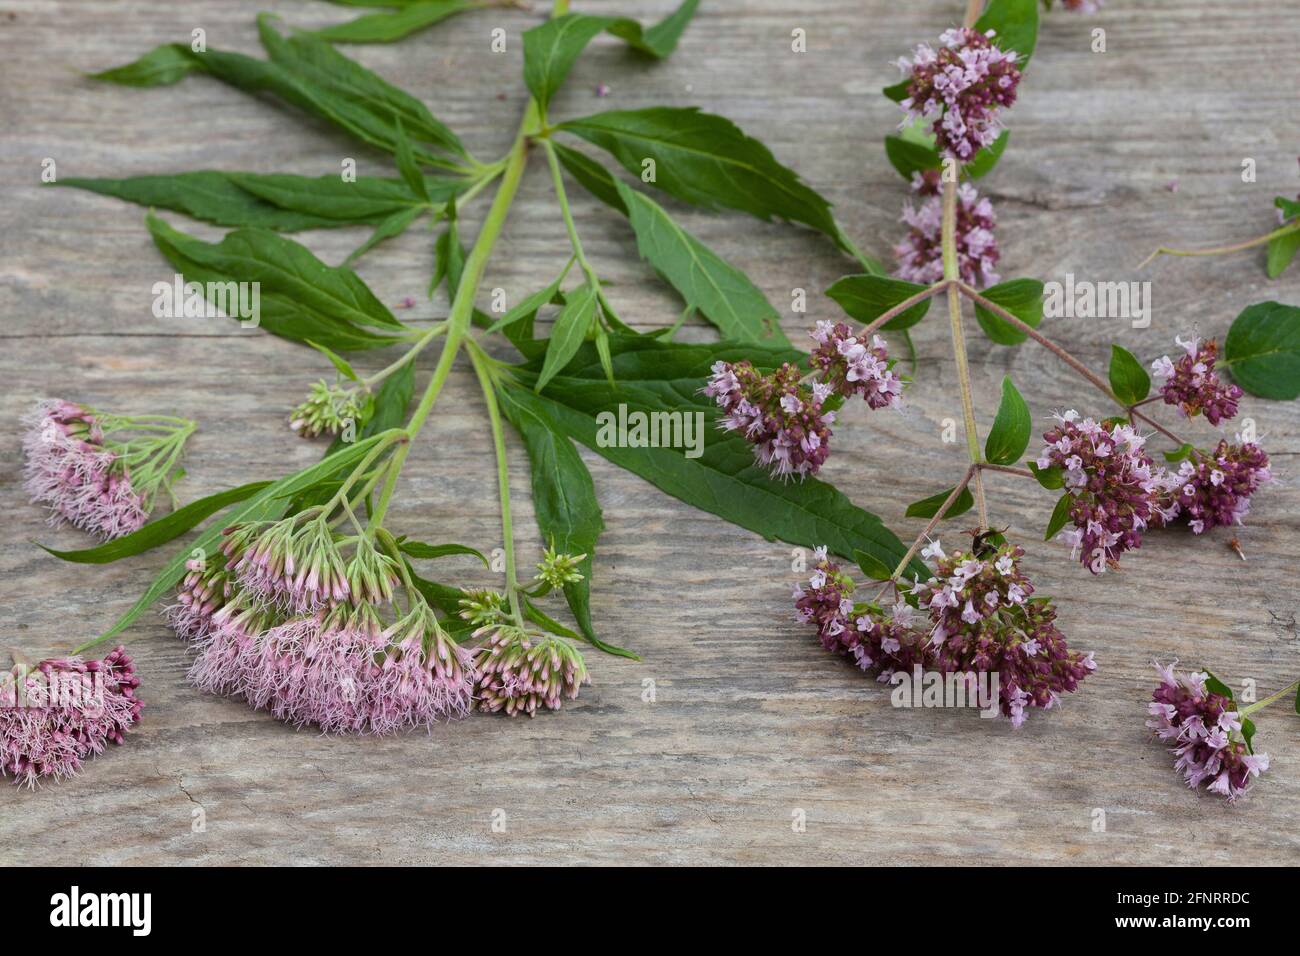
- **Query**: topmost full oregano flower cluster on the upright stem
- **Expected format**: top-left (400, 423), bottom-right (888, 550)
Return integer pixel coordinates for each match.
top-left (898, 27), bottom-right (1021, 163)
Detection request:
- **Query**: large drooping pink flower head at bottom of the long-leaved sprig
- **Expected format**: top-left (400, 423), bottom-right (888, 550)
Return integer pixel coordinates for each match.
top-left (165, 506), bottom-right (586, 735)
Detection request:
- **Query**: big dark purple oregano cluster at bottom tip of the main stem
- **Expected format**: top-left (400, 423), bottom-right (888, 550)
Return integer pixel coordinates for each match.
top-left (915, 542), bottom-right (1096, 727)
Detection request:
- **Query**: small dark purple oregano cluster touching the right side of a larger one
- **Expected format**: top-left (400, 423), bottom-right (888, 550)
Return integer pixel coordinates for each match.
top-left (1170, 440), bottom-right (1274, 535)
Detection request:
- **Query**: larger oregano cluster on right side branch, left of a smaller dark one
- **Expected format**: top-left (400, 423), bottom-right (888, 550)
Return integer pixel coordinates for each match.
top-left (1037, 410), bottom-right (1178, 574)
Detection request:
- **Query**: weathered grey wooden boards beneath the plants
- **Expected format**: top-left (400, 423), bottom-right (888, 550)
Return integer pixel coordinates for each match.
top-left (0, 0), bottom-right (1300, 865)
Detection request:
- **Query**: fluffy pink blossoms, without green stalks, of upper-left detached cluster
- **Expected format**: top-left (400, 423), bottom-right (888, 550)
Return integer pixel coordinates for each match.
top-left (22, 401), bottom-right (148, 538)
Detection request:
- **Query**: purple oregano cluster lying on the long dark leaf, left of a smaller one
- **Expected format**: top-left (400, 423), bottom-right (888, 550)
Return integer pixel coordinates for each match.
top-left (702, 362), bottom-right (835, 479)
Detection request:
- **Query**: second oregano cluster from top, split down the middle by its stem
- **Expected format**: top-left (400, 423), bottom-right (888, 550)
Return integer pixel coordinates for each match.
top-left (894, 170), bottom-right (1000, 289)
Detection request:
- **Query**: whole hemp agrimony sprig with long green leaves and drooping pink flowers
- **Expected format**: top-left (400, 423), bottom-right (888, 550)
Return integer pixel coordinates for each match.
top-left (17, 0), bottom-right (946, 780)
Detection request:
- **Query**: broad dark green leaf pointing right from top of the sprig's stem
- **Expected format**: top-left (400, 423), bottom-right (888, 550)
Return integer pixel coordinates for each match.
top-left (559, 107), bottom-right (841, 242)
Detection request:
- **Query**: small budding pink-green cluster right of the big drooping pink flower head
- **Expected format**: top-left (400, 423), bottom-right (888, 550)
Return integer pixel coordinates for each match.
top-left (475, 626), bottom-right (592, 717)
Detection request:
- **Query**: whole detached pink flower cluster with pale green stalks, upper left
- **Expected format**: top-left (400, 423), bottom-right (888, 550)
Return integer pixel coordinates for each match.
top-left (22, 399), bottom-right (194, 540)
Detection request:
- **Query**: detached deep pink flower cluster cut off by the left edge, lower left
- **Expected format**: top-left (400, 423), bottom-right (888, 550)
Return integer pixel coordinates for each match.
top-left (0, 646), bottom-right (143, 787)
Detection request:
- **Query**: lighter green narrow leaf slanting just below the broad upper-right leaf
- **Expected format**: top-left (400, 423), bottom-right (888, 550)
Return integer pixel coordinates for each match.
top-left (616, 182), bottom-right (789, 345)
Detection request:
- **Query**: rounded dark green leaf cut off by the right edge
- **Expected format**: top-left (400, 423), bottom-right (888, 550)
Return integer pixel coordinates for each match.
top-left (1218, 302), bottom-right (1300, 401)
